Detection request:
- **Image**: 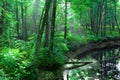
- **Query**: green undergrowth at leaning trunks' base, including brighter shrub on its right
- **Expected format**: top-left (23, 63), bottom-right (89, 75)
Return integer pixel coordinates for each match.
top-left (38, 37), bottom-right (69, 71)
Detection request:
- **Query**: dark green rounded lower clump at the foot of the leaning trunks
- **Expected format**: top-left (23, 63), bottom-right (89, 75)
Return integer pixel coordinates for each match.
top-left (38, 49), bottom-right (65, 71)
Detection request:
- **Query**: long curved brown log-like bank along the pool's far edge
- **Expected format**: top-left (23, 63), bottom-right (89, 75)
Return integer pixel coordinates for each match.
top-left (67, 39), bottom-right (120, 59)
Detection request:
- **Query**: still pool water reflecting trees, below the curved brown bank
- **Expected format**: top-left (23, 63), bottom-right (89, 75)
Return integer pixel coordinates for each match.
top-left (69, 48), bottom-right (120, 80)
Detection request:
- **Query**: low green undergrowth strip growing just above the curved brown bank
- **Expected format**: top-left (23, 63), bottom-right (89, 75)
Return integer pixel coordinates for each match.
top-left (67, 31), bottom-right (120, 51)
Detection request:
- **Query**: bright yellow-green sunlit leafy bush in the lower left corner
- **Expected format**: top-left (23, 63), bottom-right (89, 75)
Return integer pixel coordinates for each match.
top-left (0, 48), bottom-right (30, 79)
